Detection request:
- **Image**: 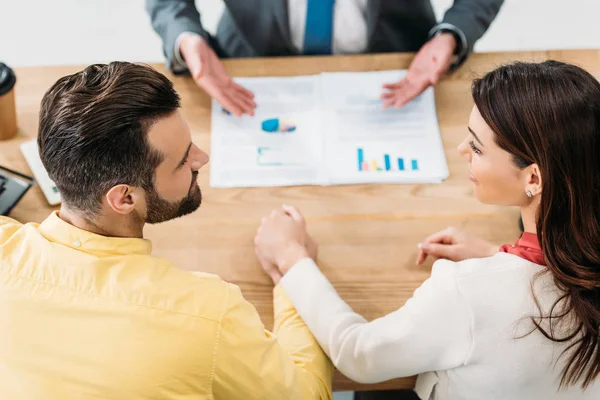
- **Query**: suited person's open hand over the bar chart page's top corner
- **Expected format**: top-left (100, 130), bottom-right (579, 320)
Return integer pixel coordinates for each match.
top-left (381, 33), bottom-right (456, 108)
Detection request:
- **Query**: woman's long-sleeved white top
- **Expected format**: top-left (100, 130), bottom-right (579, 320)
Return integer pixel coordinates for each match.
top-left (280, 253), bottom-right (600, 400)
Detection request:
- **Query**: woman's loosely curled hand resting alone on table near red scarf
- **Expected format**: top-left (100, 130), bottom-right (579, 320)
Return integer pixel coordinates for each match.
top-left (417, 228), bottom-right (500, 265)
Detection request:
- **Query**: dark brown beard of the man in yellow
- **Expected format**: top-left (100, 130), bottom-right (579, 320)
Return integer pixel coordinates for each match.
top-left (146, 172), bottom-right (202, 224)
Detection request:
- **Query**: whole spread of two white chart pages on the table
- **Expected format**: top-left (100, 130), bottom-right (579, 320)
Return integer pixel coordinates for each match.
top-left (210, 71), bottom-right (448, 187)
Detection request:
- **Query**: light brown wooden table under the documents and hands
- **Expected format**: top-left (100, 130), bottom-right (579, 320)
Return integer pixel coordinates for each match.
top-left (0, 50), bottom-right (600, 390)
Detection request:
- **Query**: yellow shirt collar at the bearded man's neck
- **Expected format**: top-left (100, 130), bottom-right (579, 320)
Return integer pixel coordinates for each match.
top-left (38, 211), bottom-right (152, 255)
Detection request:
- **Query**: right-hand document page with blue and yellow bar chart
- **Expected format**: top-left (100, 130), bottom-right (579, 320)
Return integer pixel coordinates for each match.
top-left (321, 71), bottom-right (448, 184)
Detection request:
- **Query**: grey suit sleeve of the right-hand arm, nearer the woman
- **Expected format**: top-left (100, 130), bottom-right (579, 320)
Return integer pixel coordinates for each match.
top-left (443, 0), bottom-right (504, 54)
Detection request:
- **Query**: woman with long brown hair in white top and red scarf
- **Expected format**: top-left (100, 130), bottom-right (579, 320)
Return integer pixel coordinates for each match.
top-left (256, 61), bottom-right (600, 400)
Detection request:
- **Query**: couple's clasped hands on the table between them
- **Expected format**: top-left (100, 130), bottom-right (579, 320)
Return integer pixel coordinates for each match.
top-left (254, 205), bottom-right (317, 283)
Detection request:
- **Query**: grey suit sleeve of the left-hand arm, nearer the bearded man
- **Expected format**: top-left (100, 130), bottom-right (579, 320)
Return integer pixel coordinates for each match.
top-left (146, 0), bottom-right (210, 69)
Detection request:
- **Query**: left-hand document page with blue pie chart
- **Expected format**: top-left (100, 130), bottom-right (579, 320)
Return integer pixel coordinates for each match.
top-left (210, 75), bottom-right (324, 187)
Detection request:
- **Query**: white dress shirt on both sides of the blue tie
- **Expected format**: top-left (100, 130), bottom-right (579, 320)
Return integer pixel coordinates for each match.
top-left (287, 0), bottom-right (367, 54)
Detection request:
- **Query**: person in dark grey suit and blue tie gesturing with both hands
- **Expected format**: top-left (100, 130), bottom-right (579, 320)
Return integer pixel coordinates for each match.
top-left (146, 0), bottom-right (504, 116)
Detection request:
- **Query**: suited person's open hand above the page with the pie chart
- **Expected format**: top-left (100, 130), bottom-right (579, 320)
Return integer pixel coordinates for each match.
top-left (179, 34), bottom-right (256, 117)
